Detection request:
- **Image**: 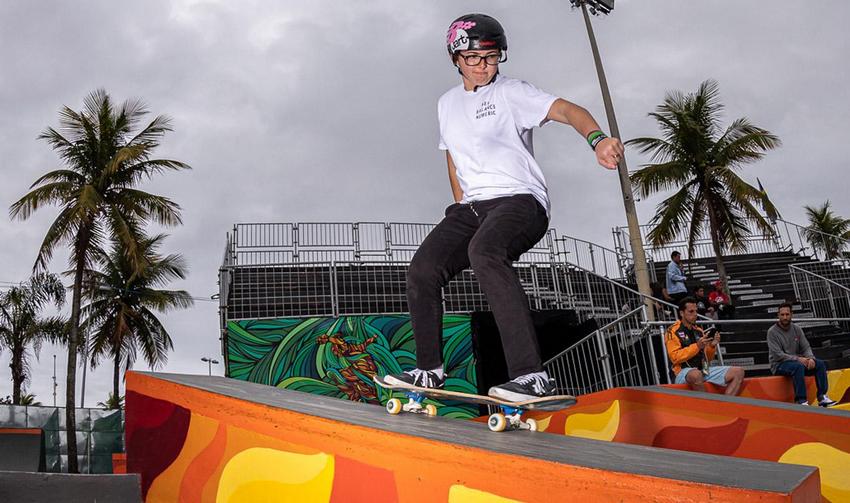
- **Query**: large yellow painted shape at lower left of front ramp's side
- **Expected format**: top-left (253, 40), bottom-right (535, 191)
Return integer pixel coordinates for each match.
top-left (216, 447), bottom-right (334, 503)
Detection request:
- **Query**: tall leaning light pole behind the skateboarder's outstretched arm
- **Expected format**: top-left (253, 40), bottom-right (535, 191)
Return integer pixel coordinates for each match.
top-left (570, 0), bottom-right (654, 321)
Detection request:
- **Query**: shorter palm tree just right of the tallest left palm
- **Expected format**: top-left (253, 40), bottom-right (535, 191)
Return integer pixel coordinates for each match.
top-left (83, 234), bottom-right (193, 404)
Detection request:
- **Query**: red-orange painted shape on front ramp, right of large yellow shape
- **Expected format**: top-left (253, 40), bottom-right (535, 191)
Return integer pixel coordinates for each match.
top-left (330, 456), bottom-right (399, 503)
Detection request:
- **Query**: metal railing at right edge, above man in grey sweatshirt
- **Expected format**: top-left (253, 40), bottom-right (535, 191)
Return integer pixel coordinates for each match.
top-left (788, 262), bottom-right (850, 330)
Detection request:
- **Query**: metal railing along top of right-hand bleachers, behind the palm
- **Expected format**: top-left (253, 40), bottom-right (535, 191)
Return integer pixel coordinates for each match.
top-left (612, 219), bottom-right (850, 261)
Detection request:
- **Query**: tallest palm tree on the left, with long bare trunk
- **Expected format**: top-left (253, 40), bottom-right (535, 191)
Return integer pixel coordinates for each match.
top-left (9, 89), bottom-right (189, 473)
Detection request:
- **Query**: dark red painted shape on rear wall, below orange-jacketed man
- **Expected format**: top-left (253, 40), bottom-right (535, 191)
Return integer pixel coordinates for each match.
top-left (652, 418), bottom-right (749, 456)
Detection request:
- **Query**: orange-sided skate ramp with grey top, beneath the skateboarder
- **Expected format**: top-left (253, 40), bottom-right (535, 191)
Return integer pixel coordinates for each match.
top-left (126, 372), bottom-right (820, 503)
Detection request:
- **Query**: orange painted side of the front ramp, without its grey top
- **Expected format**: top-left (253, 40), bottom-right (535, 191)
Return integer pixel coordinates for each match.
top-left (126, 373), bottom-right (817, 502)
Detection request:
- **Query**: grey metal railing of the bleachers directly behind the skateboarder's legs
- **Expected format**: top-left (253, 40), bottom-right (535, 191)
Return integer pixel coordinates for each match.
top-left (219, 223), bottom-right (675, 327)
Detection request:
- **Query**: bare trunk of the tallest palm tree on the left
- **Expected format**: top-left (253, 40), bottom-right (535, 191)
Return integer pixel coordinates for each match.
top-left (65, 226), bottom-right (89, 473)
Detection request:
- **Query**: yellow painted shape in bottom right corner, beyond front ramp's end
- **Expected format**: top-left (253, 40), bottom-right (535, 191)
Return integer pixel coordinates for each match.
top-left (779, 442), bottom-right (850, 501)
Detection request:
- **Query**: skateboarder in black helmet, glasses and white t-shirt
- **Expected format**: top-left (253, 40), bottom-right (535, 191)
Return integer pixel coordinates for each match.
top-left (385, 14), bottom-right (623, 401)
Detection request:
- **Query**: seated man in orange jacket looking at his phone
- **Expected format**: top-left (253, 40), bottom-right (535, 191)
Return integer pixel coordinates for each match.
top-left (664, 297), bottom-right (744, 395)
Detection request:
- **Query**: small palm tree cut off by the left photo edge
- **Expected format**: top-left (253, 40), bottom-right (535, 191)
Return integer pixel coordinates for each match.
top-left (0, 273), bottom-right (67, 405)
